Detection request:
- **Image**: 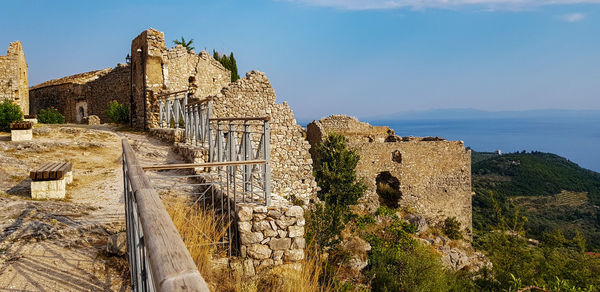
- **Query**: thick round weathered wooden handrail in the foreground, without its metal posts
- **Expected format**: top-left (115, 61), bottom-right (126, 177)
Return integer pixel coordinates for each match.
top-left (122, 138), bottom-right (209, 292)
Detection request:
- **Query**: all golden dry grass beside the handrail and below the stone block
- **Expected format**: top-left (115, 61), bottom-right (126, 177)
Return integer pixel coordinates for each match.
top-left (164, 197), bottom-right (332, 292)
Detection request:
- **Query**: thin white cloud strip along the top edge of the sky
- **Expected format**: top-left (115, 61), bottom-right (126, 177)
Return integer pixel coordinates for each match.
top-left (285, 0), bottom-right (600, 10)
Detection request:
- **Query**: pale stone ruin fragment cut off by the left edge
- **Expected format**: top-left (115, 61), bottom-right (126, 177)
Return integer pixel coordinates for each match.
top-left (0, 41), bottom-right (29, 115)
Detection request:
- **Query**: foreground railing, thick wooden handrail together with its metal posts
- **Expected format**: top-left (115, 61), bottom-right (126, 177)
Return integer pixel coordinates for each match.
top-left (122, 139), bottom-right (209, 292)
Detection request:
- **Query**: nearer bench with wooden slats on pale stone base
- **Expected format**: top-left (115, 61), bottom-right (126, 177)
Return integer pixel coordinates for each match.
top-left (29, 162), bottom-right (73, 199)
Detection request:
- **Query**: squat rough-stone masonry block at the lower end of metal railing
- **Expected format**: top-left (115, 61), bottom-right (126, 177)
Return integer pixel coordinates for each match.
top-left (237, 204), bottom-right (306, 276)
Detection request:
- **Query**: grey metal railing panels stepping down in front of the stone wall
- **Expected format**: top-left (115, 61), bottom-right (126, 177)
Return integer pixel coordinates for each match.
top-left (158, 91), bottom-right (271, 206)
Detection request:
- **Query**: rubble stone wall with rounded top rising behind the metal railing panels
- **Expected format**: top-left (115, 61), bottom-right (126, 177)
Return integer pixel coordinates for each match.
top-left (212, 71), bottom-right (317, 202)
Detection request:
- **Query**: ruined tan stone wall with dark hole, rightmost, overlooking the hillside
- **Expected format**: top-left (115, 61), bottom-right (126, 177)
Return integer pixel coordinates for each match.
top-left (307, 116), bottom-right (472, 236)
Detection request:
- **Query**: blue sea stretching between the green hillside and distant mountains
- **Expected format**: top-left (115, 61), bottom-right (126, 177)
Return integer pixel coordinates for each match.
top-left (366, 114), bottom-right (600, 172)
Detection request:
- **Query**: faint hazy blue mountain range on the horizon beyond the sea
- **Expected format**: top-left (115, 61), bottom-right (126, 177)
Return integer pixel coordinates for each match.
top-left (361, 108), bottom-right (600, 121)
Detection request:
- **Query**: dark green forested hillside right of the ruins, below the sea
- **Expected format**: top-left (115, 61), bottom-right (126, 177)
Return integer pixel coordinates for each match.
top-left (472, 151), bottom-right (600, 249)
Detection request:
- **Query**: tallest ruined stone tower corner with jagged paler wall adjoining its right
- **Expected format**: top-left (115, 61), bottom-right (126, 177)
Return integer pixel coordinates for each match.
top-left (131, 28), bottom-right (231, 128)
